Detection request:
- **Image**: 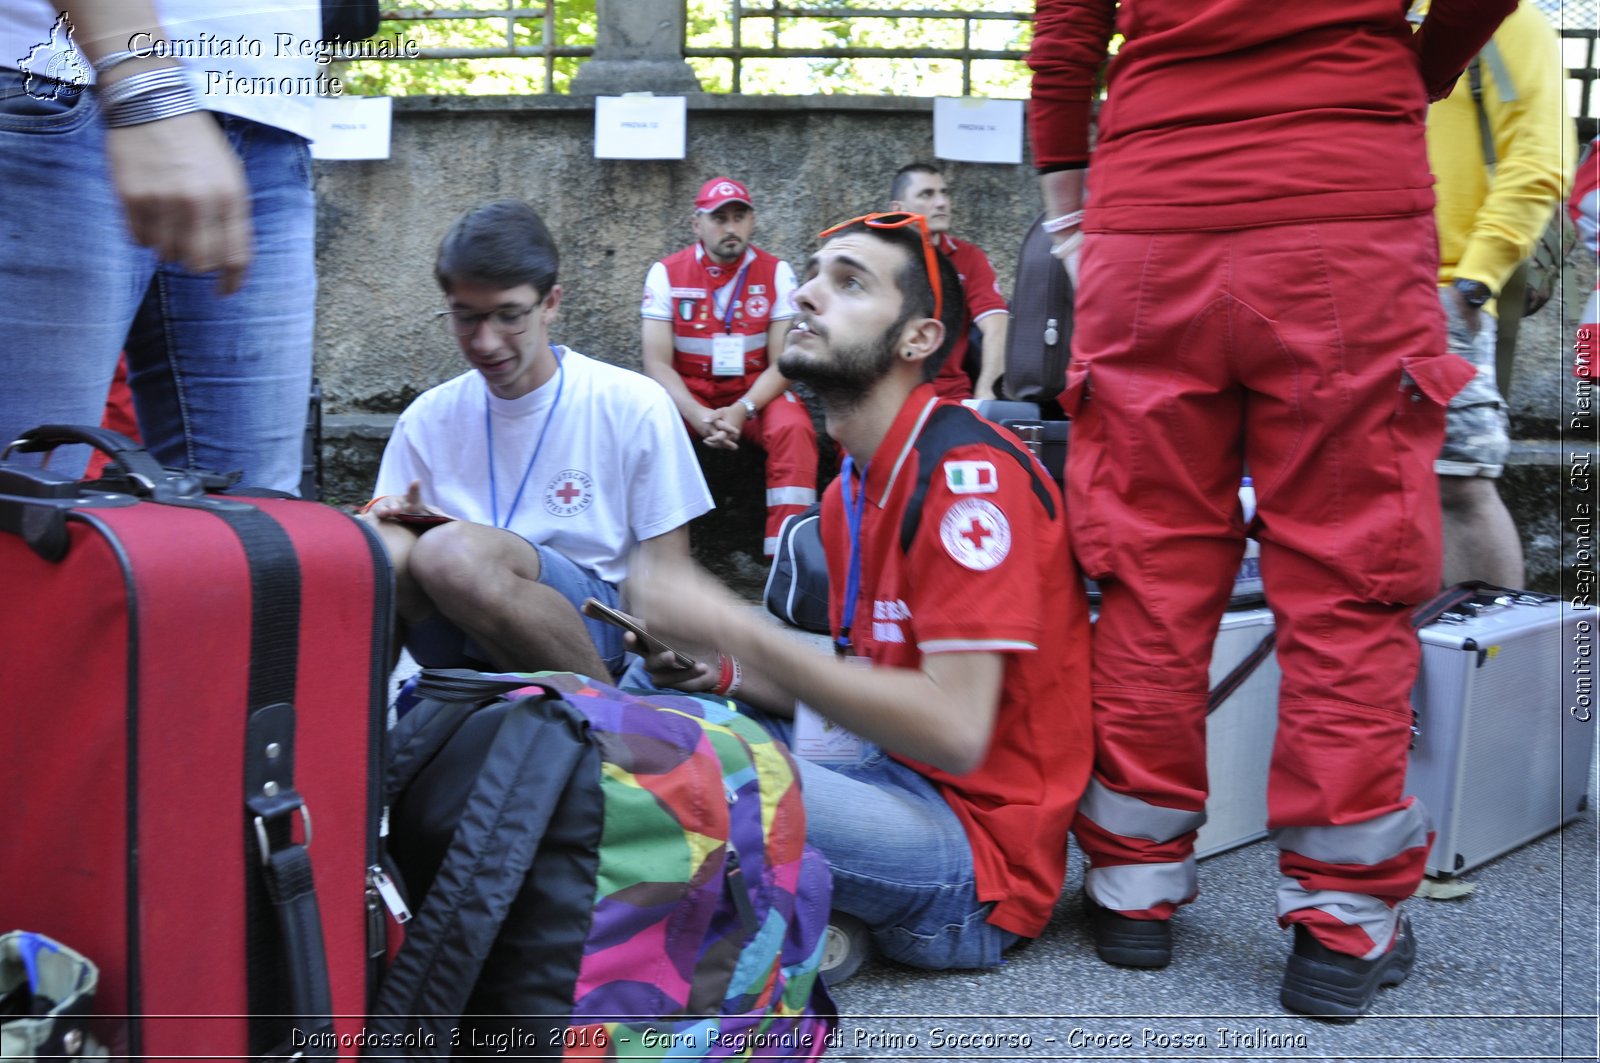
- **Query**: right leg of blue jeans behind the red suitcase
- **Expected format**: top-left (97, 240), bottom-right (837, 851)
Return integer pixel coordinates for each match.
top-left (128, 117), bottom-right (317, 491)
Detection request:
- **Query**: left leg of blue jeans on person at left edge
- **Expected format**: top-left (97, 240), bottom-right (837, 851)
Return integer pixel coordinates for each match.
top-left (0, 69), bottom-right (155, 475)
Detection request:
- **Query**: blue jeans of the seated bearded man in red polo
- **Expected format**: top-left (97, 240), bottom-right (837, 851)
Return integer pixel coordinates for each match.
top-left (744, 706), bottom-right (1019, 970)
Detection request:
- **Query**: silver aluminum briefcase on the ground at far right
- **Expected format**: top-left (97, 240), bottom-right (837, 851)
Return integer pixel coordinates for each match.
top-left (1406, 589), bottom-right (1600, 876)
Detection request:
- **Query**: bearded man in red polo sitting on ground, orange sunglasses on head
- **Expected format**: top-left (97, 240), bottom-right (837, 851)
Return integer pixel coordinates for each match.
top-left (630, 213), bottom-right (1093, 969)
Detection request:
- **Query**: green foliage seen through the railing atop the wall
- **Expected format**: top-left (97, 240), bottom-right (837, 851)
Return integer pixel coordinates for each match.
top-left (333, 0), bottom-right (1032, 98)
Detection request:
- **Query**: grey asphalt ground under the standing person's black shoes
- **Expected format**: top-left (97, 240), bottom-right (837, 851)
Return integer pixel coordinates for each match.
top-left (829, 794), bottom-right (1597, 1063)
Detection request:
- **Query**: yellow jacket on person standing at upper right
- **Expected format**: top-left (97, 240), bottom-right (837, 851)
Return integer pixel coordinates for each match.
top-left (1427, 3), bottom-right (1578, 293)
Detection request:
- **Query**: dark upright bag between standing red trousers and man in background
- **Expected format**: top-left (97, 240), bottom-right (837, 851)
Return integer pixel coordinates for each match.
top-left (1005, 213), bottom-right (1074, 405)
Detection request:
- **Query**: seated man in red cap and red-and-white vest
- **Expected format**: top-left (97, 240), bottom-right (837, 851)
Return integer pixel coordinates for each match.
top-left (640, 178), bottom-right (816, 557)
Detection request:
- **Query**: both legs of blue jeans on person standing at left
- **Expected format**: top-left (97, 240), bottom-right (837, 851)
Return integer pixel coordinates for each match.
top-left (0, 67), bottom-right (317, 491)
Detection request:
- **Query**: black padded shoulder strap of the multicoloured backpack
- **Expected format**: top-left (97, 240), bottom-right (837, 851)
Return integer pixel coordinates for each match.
top-left (366, 694), bottom-right (598, 1058)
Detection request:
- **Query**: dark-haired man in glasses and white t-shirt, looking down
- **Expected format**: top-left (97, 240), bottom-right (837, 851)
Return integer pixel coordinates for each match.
top-left (366, 200), bottom-right (712, 677)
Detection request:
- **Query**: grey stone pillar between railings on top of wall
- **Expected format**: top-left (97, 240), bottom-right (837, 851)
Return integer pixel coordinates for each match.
top-left (571, 0), bottom-right (701, 96)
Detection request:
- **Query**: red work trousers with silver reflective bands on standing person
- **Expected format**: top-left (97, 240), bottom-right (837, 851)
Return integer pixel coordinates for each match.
top-left (1062, 216), bottom-right (1472, 956)
